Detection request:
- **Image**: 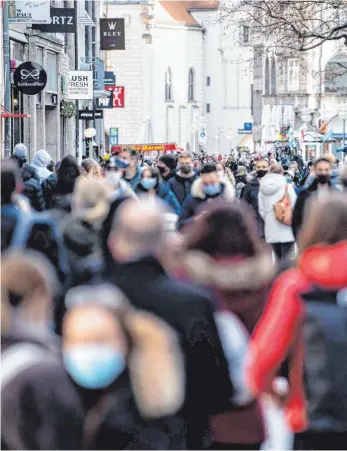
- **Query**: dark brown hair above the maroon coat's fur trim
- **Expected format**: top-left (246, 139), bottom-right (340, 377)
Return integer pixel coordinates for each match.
top-left (184, 202), bottom-right (263, 258)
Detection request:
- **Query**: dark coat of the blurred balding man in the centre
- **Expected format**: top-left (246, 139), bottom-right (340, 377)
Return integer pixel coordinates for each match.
top-left (105, 257), bottom-right (232, 449)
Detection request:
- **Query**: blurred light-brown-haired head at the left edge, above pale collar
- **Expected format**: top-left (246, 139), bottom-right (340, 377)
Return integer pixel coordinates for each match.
top-left (1, 250), bottom-right (57, 333)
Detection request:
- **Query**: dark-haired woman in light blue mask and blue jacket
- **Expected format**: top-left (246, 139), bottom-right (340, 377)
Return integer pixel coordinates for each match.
top-left (136, 168), bottom-right (181, 215)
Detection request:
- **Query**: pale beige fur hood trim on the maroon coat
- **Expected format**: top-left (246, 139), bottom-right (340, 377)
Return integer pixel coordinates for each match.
top-left (183, 251), bottom-right (276, 291)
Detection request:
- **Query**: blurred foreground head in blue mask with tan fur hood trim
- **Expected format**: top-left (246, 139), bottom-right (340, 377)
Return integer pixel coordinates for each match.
top-left (63, 285), bottom-right (184, 417)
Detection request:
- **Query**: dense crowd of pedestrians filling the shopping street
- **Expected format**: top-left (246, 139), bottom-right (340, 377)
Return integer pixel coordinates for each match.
top-left (1, 144), bottom-right (347, 450)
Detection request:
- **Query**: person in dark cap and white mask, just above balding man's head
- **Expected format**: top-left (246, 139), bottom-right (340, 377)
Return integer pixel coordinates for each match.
top-left (105, 156), bottom-right (136, 199)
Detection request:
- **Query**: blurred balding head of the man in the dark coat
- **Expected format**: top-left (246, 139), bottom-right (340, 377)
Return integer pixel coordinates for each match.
top-left (108, 196), bottom-right (168, 263)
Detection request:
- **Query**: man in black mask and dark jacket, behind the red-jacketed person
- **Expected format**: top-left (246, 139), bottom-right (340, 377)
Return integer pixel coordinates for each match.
top-left (292, 157), bottom-right (337, 237)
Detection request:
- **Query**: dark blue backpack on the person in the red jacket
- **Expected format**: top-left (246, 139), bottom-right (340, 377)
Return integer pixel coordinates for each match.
top-left (302, 288), bottom-right (347, 433)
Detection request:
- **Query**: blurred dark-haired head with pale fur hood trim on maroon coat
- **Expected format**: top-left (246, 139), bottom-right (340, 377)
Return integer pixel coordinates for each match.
top-left (182, 202), bottom-right (275, 291)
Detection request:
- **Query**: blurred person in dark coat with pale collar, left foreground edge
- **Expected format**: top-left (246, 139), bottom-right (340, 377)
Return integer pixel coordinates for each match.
top-left (1, 251), bottom-right (82, 450)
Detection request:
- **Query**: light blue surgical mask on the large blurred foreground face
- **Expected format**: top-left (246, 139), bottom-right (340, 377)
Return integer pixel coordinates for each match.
top-left (63, 344), bottom-right (126, 390)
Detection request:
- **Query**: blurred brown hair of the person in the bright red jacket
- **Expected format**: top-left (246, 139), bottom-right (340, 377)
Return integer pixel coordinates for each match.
top-left (298, 193), bottom-right (347, 252)
